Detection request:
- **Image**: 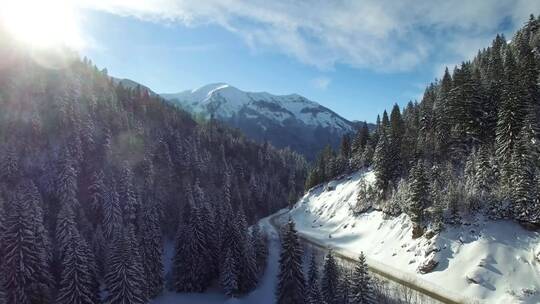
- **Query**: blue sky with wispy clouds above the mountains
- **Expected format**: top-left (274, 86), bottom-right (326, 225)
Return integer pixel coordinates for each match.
top-left (79, 0), bottom-right (540, 121)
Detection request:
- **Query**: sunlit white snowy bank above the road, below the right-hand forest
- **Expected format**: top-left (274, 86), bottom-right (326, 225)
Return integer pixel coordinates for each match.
top-left (282, 172), bottom-right (540, 304)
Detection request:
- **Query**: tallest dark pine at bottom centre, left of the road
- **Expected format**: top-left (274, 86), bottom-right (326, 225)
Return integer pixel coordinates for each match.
top-left (276, 220), bottom-right (305, 304)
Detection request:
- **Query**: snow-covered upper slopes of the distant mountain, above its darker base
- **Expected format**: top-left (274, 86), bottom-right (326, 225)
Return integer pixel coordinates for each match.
top-left (160, 83), bottom-right (353, 133)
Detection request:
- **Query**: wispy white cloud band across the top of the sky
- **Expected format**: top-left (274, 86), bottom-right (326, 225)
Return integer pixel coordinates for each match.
top-left (77, 0), bottom-right (540, 71)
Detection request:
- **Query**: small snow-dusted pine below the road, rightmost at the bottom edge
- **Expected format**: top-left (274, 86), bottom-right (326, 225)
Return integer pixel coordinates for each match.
top-left (350, 252), bottom-right (375, 304)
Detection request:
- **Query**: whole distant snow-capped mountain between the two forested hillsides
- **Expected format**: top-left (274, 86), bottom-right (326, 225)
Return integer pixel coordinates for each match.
top-left (160, 83), bottom-right (355, 159)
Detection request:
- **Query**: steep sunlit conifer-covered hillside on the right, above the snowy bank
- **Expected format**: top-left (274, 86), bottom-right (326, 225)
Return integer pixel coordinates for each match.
top-left (306, 15), bottom-right (540, 234)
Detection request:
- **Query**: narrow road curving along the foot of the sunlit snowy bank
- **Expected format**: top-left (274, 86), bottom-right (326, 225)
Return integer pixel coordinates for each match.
top-left (269, 212), bottom-right (464, 304)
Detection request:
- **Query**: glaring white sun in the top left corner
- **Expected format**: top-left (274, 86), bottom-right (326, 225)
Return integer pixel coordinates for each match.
top-left (0, 0), bottom-right (84, 50)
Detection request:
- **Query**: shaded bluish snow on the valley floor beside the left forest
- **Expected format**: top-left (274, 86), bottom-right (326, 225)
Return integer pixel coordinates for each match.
top-left (150, 213), bottom-right (280, 304)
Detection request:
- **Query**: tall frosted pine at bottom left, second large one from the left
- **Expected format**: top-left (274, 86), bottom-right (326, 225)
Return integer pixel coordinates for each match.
top-left (55, 205), bottom-right (99, 304)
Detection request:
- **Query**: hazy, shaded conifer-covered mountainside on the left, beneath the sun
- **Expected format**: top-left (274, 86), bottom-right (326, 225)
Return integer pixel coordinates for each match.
top-left (0, 32), bottom-right (305, 304)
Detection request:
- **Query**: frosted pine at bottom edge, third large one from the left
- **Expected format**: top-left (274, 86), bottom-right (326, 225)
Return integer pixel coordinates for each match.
top-left (104, 225), bottom-right (148, 304)
